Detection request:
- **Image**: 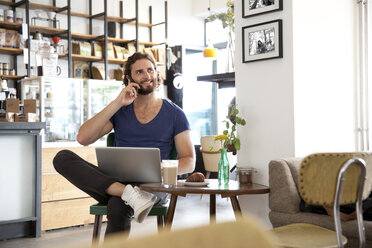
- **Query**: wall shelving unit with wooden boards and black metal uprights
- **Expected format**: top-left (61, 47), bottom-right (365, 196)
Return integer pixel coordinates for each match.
top-left (0, 0), bottom-right (168, 78)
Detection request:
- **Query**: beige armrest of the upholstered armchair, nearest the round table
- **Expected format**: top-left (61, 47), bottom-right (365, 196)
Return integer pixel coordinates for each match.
top-left (269, 159), bottom-right (301, 213)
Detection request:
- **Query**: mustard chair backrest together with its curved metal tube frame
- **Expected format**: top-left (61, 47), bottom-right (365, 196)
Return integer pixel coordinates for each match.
top-left (298, 153), bottom-right (372, 247)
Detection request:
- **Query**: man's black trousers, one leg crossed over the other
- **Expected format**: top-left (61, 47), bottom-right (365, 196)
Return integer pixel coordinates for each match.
top-left (53, 150), bottom-right (133, 235)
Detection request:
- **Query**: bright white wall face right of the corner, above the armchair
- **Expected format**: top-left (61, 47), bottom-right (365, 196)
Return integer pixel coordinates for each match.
top-left (293, 0), bottom-right (356, 156)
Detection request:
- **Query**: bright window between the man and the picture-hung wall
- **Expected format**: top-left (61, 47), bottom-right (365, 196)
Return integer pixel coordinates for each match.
top-left (182, 20), bottom-right (236, 144)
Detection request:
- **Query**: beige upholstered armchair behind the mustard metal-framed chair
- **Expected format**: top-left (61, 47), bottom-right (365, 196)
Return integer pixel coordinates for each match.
top-left (269, 158), bottom-right (372, 247)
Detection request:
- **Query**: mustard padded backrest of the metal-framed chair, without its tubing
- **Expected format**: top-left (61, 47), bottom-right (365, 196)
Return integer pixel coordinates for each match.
top-left (298, 153), bottom-right (372, 206)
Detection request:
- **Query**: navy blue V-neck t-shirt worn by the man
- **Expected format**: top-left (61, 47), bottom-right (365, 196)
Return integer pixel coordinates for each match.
top-left (110, 99), bottom-right (190, 159)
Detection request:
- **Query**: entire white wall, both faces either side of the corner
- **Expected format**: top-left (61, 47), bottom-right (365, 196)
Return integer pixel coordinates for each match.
top-left (235, 0), bottom-right (355, 227)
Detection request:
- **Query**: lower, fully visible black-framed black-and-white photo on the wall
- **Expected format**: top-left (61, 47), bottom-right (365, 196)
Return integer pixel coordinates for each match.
top-left (242, 20), bottom-right (283, 63)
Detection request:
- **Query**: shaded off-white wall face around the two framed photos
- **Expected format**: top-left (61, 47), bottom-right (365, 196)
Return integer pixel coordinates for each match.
top-left (235, 1), bottom-right (295, 227)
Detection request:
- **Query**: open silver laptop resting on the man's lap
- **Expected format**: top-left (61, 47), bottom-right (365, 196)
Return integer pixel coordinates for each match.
top-left (96, 147), bottom-right (161, 183)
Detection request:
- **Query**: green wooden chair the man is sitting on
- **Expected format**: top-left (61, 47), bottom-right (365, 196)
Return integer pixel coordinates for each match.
top-left (90, 133), bottom-right (173, 242)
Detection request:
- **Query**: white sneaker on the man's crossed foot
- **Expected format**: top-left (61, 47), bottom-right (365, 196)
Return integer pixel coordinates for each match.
top-left (121, 184), bottom-right (156, 223)
